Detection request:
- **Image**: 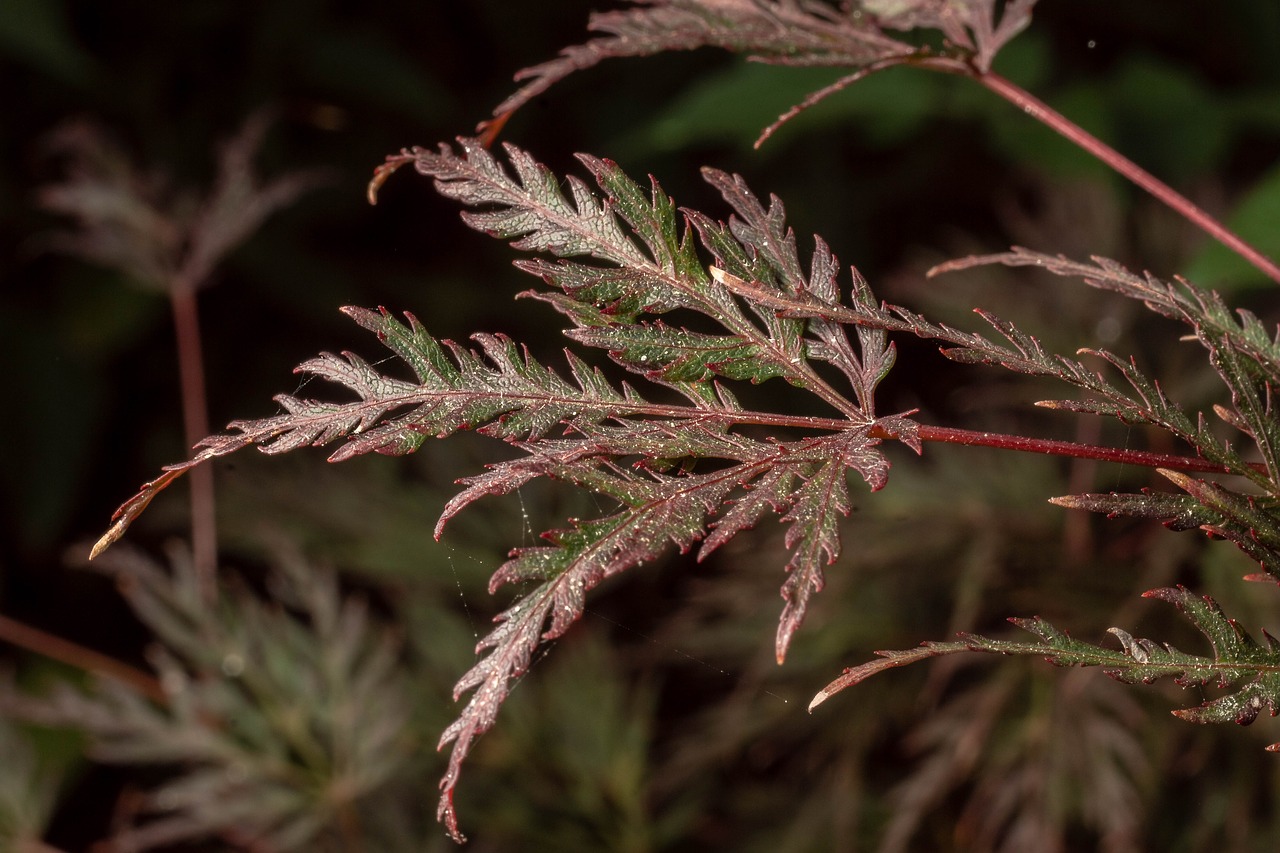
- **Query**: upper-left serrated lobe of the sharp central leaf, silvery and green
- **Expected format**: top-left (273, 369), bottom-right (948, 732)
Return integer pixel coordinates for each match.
top-left (397, 140), bottom-right (860, 414)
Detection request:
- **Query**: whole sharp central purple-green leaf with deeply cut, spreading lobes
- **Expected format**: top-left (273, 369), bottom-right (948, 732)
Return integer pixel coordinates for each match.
top-left (95, 140), bottom-right (920, 839)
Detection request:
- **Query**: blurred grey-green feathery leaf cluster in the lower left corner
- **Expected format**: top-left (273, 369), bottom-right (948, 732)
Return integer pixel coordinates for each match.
top-left (6, 551), bottom-right (417, 850)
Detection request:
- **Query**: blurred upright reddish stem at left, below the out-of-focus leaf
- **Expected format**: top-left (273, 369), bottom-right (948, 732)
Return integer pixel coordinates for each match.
top-left (169, 279), bottom-right (218, 603)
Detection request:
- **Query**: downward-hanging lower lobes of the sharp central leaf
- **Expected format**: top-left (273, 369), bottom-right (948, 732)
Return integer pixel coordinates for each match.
top-left (438, 414), bottom-right (906, 838)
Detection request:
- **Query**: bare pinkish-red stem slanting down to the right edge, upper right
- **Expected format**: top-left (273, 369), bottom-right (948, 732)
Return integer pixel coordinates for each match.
top-left (970, 70), bottom-right (1280, 283)
